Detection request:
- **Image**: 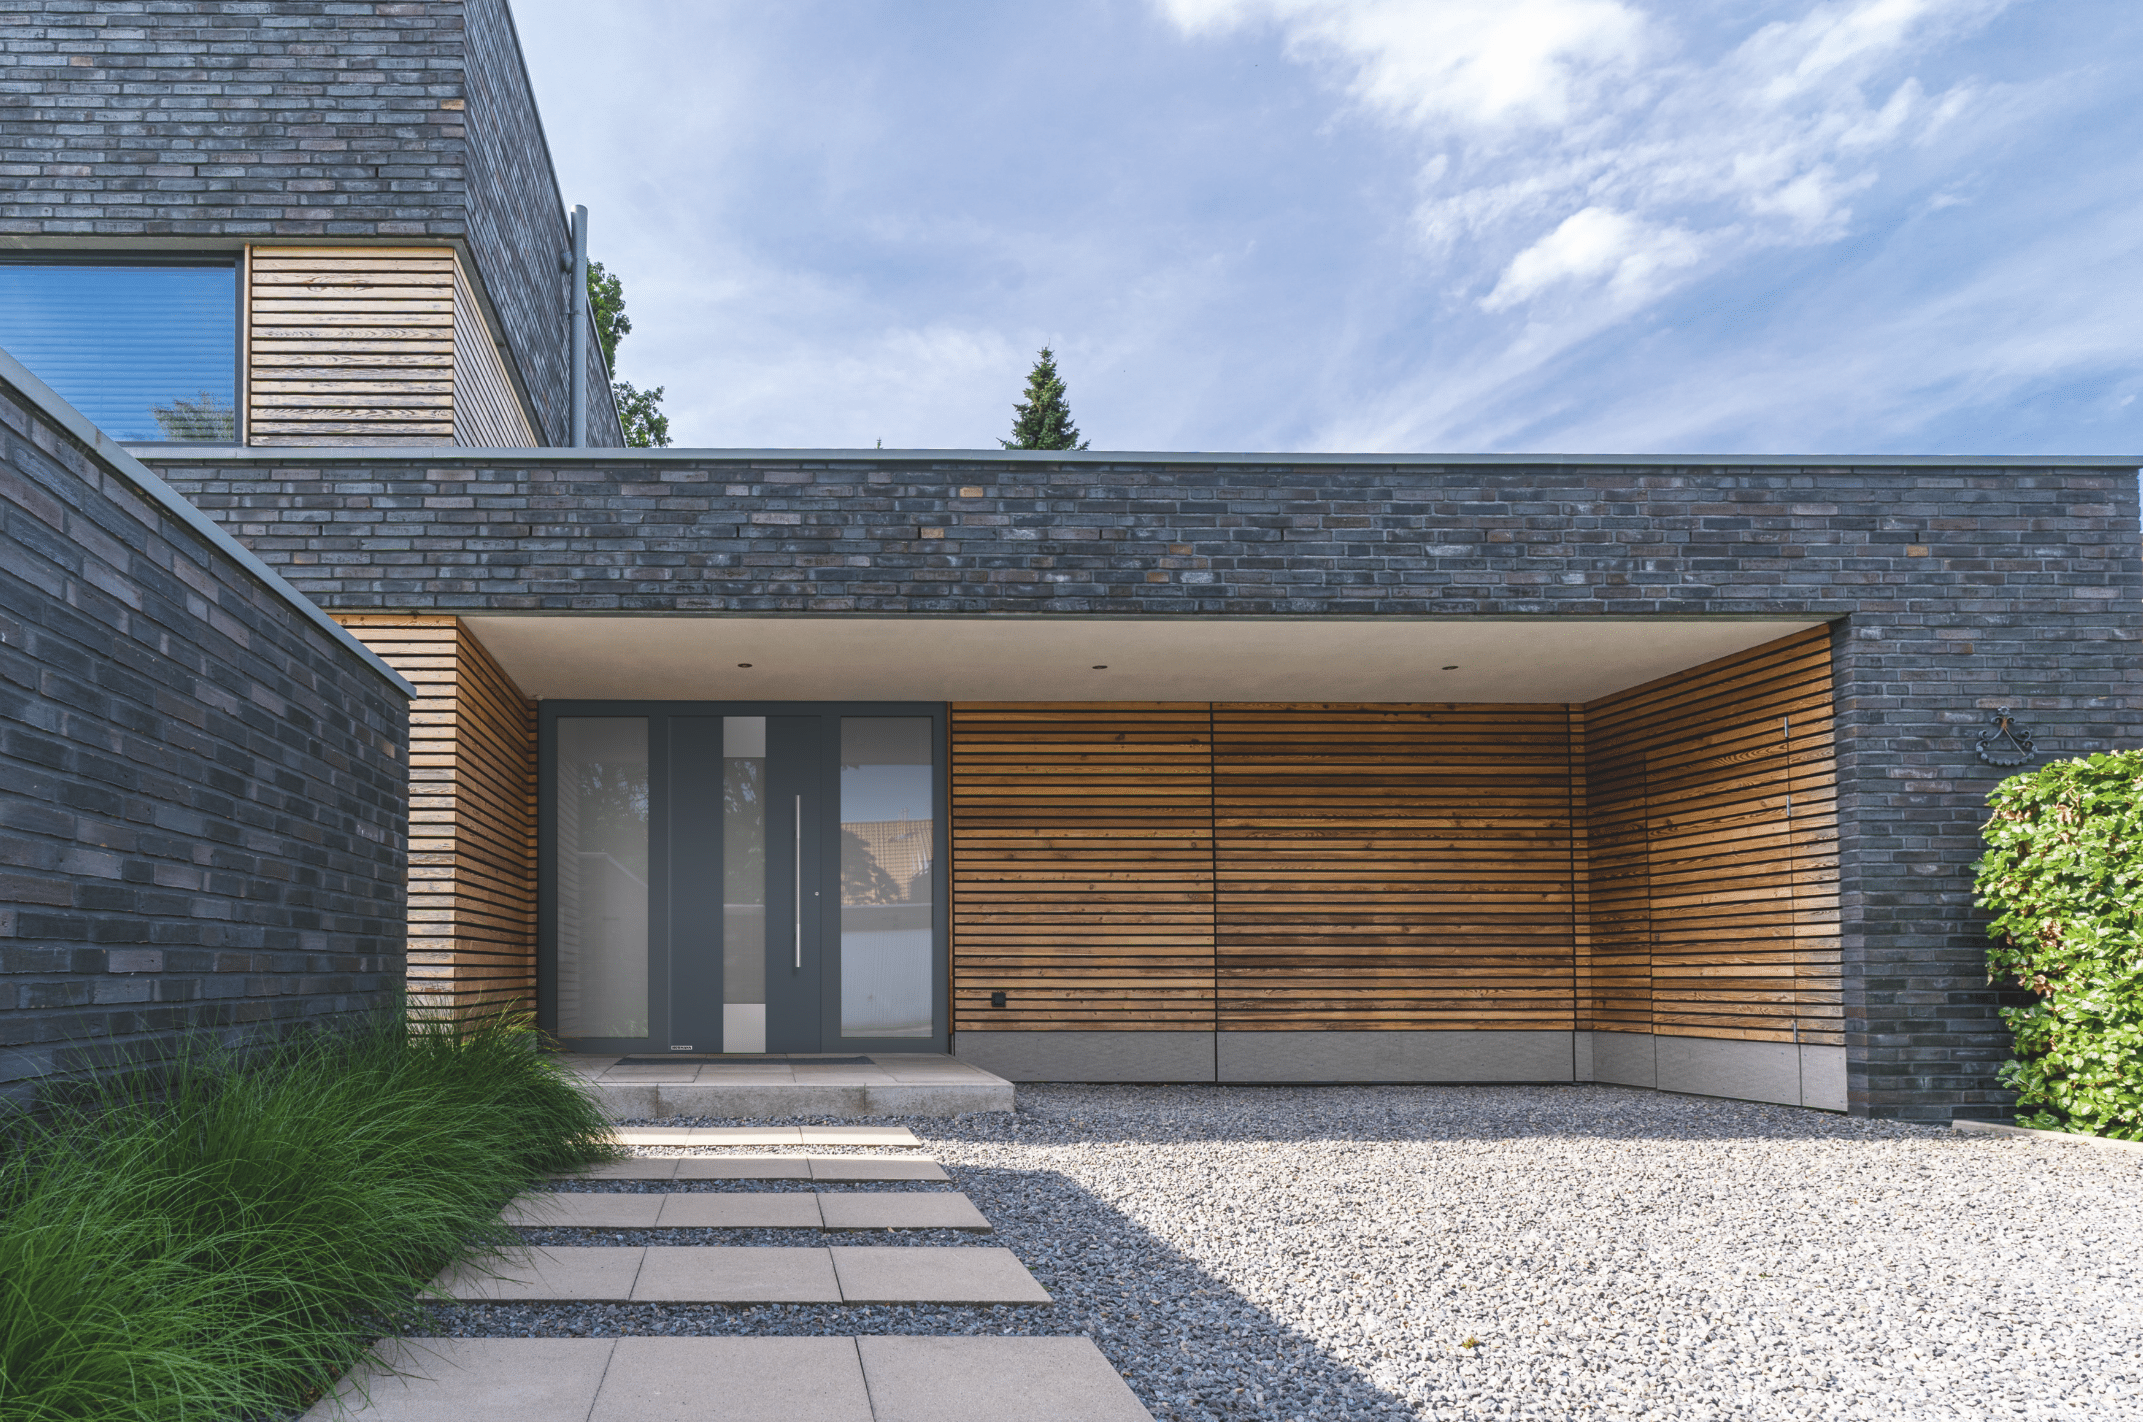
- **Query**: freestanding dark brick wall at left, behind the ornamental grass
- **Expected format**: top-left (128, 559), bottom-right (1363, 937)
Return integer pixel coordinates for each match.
top-left (0, 374), bottom-right (407, 1101)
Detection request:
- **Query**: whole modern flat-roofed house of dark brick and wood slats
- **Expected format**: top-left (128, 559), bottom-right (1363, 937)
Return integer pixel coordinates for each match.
top-left (0, 0), bottom-right (2143, 1120)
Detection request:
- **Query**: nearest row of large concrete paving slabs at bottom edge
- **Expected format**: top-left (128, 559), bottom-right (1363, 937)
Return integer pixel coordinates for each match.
top-left (304, 1338), bottom-right (1153, 1422)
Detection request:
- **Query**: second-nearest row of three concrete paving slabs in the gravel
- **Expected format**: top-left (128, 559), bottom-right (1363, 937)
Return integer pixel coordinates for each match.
top-left (433, 1244), bottom-right (1050, 1304)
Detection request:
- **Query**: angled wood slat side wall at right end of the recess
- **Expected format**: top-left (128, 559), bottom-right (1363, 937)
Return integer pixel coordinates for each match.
top-left (1579, 627), bottom-right (1845, 1045)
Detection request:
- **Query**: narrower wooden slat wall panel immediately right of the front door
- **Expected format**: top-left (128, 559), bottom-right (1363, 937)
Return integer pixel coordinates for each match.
top-left (951, 702), bottom-right (1213, 1032)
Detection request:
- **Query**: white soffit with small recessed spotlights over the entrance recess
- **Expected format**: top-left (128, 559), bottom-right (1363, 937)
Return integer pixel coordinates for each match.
top-left (463, 615), bottom-right (1819, 702)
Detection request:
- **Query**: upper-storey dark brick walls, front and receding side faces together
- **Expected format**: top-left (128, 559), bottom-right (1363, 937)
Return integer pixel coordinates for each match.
top-left (0, 0), bottom-right (624, 445)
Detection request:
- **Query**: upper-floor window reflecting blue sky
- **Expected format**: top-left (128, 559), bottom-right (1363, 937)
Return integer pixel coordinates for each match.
top-left (0, 259), bottom-right (238, 443)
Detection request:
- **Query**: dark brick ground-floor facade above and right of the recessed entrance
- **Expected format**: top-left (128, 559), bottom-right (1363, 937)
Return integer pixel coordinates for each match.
top-left (146, 454), bottom-right (2143, 1120)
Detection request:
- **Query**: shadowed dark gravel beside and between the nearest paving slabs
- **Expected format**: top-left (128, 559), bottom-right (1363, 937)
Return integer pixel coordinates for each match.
top-left (435, 1165), bottom-right (1414, 1422)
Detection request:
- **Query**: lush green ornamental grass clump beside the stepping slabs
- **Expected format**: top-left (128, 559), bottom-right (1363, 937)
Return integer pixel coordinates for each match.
top-left (0, 1015), bottom-right (613, 1422)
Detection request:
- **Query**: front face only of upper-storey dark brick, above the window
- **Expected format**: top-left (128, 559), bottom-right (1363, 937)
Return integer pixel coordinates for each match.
top-left (0, 0), bottom-right (467, 238)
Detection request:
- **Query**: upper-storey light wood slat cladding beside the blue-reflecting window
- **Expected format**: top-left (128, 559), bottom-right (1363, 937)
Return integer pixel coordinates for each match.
top-left (244, 246), bottom-right (536, 448)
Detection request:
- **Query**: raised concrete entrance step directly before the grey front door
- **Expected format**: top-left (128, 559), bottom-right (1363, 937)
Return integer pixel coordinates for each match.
top-left (561, 1052), bottom-right (1014, 1120)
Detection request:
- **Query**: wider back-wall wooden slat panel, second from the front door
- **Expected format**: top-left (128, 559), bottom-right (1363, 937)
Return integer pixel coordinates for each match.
top-left (1213, 705), bottom-right (1579, 1032)
